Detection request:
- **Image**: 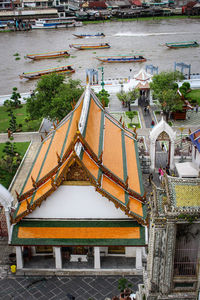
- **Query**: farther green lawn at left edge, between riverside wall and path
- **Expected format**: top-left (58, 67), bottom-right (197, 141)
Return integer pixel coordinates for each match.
top-left (0, 104), bottom-right (42, 132)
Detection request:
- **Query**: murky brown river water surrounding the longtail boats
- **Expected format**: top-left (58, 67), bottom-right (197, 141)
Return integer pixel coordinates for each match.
top-left (0, 19), bottom-right (200, 95)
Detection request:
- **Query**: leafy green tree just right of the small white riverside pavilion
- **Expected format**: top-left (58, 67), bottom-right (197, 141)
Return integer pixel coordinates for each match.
top-left (150, 72), bottom-right (184, 121)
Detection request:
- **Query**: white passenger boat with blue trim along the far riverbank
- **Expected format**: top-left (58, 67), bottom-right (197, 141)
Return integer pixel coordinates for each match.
top-left (32, 17), bottom-right (83, 29)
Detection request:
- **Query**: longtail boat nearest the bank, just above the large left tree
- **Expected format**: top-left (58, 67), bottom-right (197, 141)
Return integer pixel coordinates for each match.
top-left (19, 66), bottom-right (75, 79)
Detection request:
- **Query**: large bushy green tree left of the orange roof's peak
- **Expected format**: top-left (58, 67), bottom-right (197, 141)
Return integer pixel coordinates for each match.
top-left (27, 74), bottom-right (83, 121)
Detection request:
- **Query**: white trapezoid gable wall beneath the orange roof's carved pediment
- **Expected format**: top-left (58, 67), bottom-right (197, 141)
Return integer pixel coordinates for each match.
top-left (27, 185), bottom-right (128, 219)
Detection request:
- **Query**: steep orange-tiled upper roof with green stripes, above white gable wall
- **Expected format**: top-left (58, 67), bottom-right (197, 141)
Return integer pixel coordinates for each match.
top-left (12, 86), bottom-right (146, 224)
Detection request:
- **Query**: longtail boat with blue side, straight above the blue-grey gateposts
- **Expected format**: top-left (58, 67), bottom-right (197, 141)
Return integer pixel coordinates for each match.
top-left (96, 55), bottom-right (146, 63)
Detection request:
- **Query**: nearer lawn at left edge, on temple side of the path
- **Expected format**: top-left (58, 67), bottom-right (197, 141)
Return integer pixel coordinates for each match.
top-left (0, 142), bottom-right (29, 188)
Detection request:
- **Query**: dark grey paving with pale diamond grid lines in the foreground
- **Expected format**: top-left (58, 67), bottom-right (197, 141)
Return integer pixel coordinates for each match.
top-left (0, 275), bottom-right (142, 300)
